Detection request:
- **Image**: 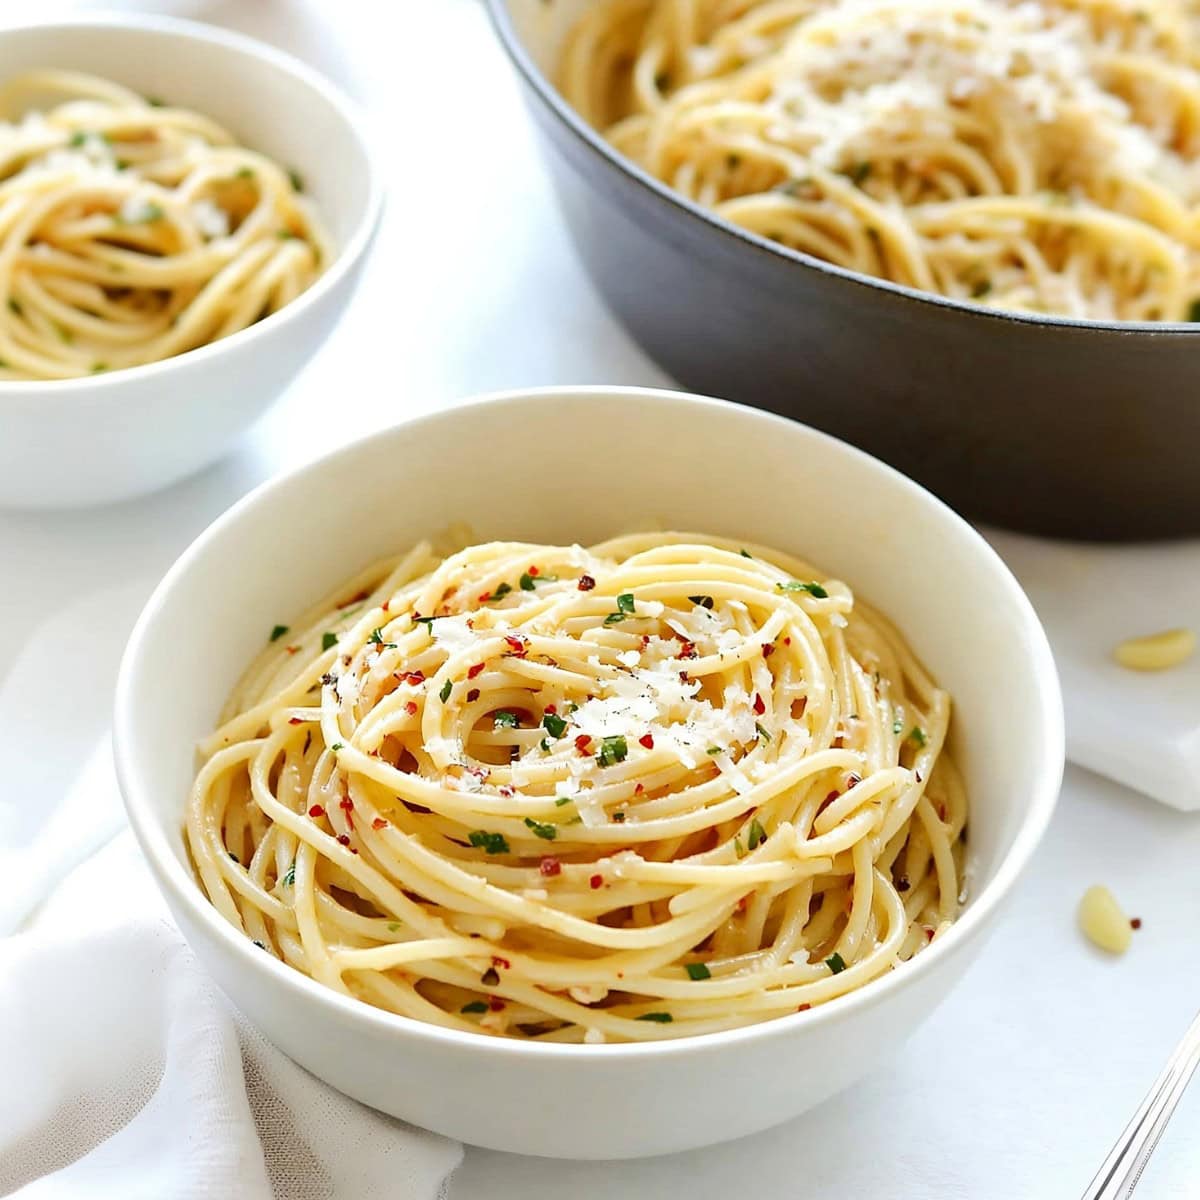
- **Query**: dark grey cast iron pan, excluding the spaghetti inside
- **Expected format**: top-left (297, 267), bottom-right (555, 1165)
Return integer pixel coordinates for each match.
top-left (486, 0), bottom-right (1200, 539)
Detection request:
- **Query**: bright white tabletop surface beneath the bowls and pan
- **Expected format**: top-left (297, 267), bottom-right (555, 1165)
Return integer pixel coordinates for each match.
top-left (0, 0), bottom-right (1200, 1200)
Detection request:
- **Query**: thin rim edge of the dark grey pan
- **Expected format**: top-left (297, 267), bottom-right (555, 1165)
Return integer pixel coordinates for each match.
top-left (484, 0), bottom-right (1200, 337)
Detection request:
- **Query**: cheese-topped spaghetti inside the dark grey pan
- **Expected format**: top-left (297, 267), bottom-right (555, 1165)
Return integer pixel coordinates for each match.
top-left (562, 0), bottom-right (1200, 320)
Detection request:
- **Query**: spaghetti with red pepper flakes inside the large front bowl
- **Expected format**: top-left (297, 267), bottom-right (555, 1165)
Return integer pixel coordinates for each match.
top-left (186, 534), bottom-right (966, 1043)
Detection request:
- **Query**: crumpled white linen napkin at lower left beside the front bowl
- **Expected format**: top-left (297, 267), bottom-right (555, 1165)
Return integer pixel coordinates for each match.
top-left (0, 745), bottom-right (462, 1200)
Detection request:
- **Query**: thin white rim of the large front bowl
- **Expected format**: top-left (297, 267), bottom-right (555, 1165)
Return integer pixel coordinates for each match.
top-left (113, 384), bottom-right (1066, 1063)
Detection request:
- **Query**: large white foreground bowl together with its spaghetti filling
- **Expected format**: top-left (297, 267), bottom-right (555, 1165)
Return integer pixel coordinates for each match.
top-left (114, 388), bottom-right (1063, 1158)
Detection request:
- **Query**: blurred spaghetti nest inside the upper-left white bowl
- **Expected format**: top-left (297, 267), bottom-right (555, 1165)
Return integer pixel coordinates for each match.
top-left (0, 71), bottom-right (331, 380)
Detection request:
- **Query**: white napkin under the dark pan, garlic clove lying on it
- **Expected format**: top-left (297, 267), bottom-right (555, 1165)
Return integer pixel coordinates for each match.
top-left (984, 529), bottom-right (1200, 810)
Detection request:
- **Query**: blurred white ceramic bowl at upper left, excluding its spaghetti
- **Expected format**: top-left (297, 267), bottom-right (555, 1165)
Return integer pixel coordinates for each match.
top-left (0, 14), bottom-right (382, 508)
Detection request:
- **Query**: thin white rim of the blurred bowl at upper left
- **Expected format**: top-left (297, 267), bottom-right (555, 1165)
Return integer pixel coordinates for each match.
top-left (0, 12), bottom-right (384, 406)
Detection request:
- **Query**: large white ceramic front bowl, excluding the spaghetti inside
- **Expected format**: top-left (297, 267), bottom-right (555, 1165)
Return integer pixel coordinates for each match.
top-left (114, 388), bottom-right (1063, 1158)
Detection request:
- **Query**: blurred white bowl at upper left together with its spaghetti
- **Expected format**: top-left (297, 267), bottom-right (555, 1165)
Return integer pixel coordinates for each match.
top-left (0, 16), bottom-right (380, 508)
